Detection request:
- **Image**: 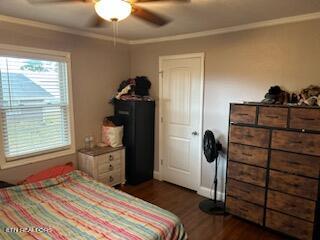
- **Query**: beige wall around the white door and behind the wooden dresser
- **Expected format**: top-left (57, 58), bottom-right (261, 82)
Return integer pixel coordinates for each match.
top-left (131, 20), bottom-right (320, 190)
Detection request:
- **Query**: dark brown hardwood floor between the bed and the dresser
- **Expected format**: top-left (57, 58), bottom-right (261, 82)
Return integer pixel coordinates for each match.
top-left (120, 180), bottom-right (285, 240)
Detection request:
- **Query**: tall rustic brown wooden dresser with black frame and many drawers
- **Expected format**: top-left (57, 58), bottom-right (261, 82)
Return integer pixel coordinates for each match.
top-left (226, 104), bottom-right (320, 239)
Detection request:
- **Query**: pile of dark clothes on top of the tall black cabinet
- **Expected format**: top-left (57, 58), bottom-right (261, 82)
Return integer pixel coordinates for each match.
top-left (110, 76), bottom-right (153, 103)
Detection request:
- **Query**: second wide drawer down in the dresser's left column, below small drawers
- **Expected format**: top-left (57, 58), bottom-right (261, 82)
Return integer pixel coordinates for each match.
top-left (229, 143), bottom-right (268, 167)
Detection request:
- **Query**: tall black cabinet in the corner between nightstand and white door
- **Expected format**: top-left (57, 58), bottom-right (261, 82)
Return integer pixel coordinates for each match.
top-left (114, 100), bottom-right (155, 185)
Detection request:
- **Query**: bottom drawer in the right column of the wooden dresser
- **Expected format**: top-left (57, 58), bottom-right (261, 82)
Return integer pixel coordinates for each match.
top-left (266, 210), bottom-right (313, 240)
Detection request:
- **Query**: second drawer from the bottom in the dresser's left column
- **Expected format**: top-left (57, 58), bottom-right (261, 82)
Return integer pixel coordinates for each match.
top-left (227, 178), bottom-right (265, 206)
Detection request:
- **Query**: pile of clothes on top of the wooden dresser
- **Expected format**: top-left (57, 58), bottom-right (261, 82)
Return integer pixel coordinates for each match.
top-left (262, 85), bottom-right (320, 106)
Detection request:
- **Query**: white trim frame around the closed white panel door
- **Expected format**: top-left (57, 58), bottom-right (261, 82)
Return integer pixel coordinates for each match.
top-left (158, 52), bottom-right (205, 192)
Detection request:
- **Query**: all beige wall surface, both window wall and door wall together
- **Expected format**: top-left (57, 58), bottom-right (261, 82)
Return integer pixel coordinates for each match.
top-left (0, 17), bottom-right (320, 187)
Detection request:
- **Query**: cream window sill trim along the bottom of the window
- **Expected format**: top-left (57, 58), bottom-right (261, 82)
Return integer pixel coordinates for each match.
top-left (0, 146), bottom-right (76, 169)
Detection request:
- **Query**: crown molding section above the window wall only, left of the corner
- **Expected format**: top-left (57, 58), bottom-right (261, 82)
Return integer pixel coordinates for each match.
top-left (0, 15), bottom-right (129, 44)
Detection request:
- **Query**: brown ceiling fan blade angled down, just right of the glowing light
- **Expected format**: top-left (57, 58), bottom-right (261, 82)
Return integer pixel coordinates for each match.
top-left (132, 6), bottom-right (170, 26)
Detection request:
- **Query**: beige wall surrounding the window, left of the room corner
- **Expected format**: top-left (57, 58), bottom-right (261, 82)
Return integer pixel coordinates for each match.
top-left (0, 22), bottom-right (130, 182)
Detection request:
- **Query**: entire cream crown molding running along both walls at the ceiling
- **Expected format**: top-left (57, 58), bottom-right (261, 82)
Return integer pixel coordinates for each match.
top-left (0, 12), bottom-right (320, 45)
